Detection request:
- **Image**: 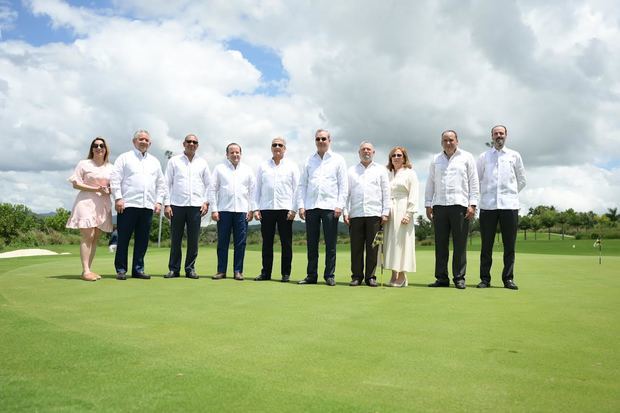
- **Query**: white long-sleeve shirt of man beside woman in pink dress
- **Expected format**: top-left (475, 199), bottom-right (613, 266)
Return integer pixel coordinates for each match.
top-left (110, 149), bottom-right (166, 209)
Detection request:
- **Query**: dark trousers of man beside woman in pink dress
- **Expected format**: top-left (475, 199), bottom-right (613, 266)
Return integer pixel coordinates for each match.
top-left (114, 207), bottom-right (153, 274)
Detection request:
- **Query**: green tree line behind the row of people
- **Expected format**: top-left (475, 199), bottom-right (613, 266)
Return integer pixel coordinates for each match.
top-left (0, 203), bottom-right (620, 249)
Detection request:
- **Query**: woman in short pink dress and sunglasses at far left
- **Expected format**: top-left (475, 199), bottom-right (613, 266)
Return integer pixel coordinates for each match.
top-left (67, 137), bottom-right (112, 281)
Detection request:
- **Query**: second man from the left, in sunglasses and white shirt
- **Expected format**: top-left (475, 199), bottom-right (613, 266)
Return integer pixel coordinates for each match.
top-left (164, 134), bottom-right (211, 279)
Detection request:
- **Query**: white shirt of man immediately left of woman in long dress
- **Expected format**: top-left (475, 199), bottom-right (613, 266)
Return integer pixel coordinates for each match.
top-left (345, 162), bottom-right (392, 218)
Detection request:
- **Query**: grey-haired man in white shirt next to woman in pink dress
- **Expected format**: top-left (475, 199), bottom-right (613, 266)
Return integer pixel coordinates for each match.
top-left (110, 130), bottom-right (166, 280)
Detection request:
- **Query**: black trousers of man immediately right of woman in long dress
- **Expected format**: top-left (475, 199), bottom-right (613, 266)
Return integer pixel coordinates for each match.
top-left (433, 205), bottom-right (469, 282)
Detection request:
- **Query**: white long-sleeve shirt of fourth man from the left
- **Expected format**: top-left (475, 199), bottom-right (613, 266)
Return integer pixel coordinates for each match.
top-left (256, 159), bottom-right (299, 211)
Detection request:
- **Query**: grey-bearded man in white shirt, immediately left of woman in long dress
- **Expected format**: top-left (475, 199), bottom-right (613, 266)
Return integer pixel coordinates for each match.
top-left (344, 141), bottom-right (392, 287)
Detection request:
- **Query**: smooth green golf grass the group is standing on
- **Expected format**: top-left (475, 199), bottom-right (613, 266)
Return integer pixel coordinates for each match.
top-left (0, 241), bottom-right (620, 412)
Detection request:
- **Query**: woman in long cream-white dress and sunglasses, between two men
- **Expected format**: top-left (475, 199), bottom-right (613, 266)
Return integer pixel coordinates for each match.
top-left (384, 146), bottom-right (418, 287)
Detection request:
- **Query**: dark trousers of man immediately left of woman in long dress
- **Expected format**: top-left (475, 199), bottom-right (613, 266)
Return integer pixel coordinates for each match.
top-left (349, 217), bottom-right (381, 281)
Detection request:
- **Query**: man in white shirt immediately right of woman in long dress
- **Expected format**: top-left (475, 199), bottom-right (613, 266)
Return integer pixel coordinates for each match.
top-left (424, 130), bottom-right (480, 290)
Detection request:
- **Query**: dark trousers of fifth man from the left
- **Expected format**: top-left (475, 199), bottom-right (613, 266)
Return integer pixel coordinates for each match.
top-left (306, 208), bottom-right (338, 280)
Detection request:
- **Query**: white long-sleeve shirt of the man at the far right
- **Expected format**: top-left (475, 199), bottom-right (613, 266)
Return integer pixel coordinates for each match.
top-left (477, 147), bottom-right (526, 209)
